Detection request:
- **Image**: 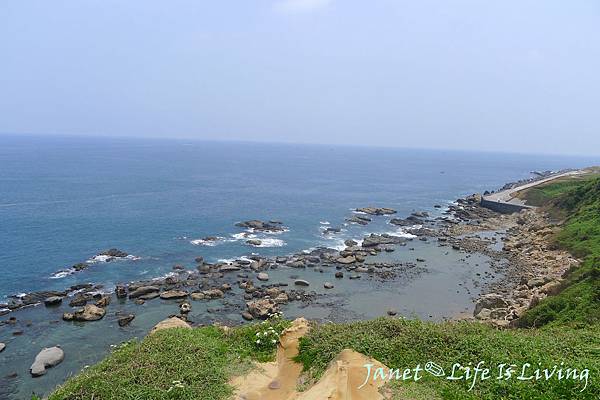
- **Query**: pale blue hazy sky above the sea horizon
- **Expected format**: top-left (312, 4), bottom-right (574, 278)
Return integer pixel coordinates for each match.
top-left (0, 0), bottom-right (600, 154)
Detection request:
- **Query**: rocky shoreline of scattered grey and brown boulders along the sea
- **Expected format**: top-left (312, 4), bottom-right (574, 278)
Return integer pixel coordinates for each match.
top-left (0, 183), bottom-right (578, 374)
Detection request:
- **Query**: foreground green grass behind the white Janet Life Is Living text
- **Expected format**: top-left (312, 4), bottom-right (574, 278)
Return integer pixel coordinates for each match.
top-left (298, 318), bottom-right (600, 399)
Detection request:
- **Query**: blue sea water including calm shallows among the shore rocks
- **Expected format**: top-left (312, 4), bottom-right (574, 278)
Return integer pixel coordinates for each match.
top-left (0, 136), bottom-right (597, 399)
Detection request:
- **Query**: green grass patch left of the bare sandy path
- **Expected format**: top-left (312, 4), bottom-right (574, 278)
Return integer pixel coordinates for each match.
top-left (49, 321), bottom-right (289, 400)
